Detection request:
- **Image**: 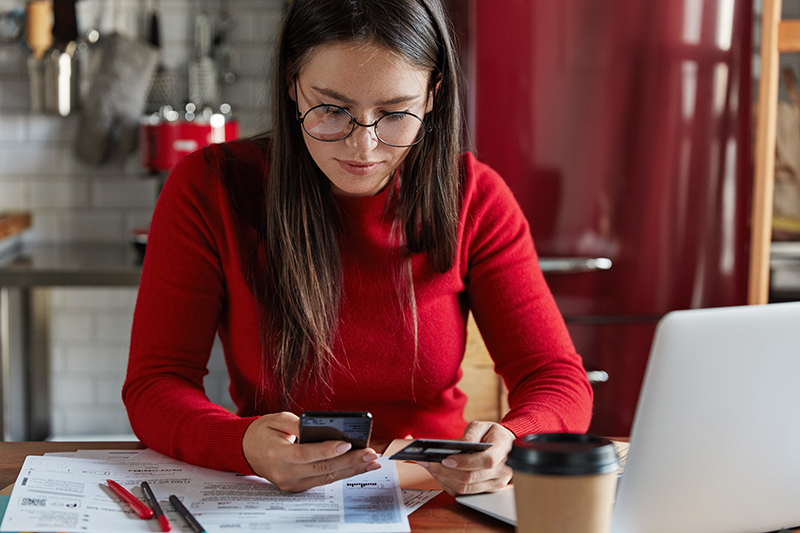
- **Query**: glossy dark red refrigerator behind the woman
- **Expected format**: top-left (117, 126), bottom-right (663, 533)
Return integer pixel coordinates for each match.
top-left (460, 0), bottom-right (753, 436)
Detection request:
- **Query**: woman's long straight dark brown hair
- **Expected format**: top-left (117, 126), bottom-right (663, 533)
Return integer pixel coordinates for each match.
top-left (264, 0), bottom-right (461, 407)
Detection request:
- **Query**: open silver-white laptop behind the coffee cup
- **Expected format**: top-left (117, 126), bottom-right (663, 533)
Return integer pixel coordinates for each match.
top-left (457, 302), bottom-right (800, 533)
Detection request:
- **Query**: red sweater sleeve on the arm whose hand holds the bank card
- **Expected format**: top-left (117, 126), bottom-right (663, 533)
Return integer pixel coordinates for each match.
top-left (462, 154), bottom-right (592, 436)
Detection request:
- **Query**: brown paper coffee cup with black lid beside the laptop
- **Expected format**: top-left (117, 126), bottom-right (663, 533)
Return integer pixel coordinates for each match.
top-left (506, 433), bottom-right (619, 533)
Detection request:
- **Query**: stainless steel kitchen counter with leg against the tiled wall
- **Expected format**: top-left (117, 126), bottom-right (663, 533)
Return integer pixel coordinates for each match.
top-left (0, 243), bottom-right (142, 441)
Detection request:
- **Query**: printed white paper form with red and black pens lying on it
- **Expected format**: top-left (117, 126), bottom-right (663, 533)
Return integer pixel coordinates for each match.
top-left (0, 450), bottom-right (410, 533)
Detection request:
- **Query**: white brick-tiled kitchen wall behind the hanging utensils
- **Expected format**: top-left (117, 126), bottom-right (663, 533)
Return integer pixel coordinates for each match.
top-left (0, 0), bottom-right (285, 438)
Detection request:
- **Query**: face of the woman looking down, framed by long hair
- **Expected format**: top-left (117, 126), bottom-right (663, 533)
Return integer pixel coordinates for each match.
top-left (290, 42), bottom-right (432, 196)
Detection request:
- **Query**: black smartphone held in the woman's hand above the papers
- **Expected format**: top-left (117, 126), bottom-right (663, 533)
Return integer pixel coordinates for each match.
top-left (298, 411), bottom-right (372, 450)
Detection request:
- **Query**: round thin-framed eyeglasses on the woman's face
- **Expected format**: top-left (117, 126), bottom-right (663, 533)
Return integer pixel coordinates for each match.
top-left (294, 78), bottom-right (435, 148)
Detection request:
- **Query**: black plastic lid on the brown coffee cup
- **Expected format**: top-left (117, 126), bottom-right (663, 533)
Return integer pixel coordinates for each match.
top-left (506, 433), bottom-right (619, 476)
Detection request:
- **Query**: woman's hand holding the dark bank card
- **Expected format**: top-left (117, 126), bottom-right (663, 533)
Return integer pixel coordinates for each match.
top-left (419, 422), bottom-right (516, 496)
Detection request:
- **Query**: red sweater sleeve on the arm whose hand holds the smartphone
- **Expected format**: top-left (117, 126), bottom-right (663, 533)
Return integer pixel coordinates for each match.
top-left (122, 153), bottom-right (254, 474)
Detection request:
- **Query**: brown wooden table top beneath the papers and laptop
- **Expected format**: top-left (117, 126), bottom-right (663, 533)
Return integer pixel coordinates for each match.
top-left (0, 442), bottom-right (514, 533)
